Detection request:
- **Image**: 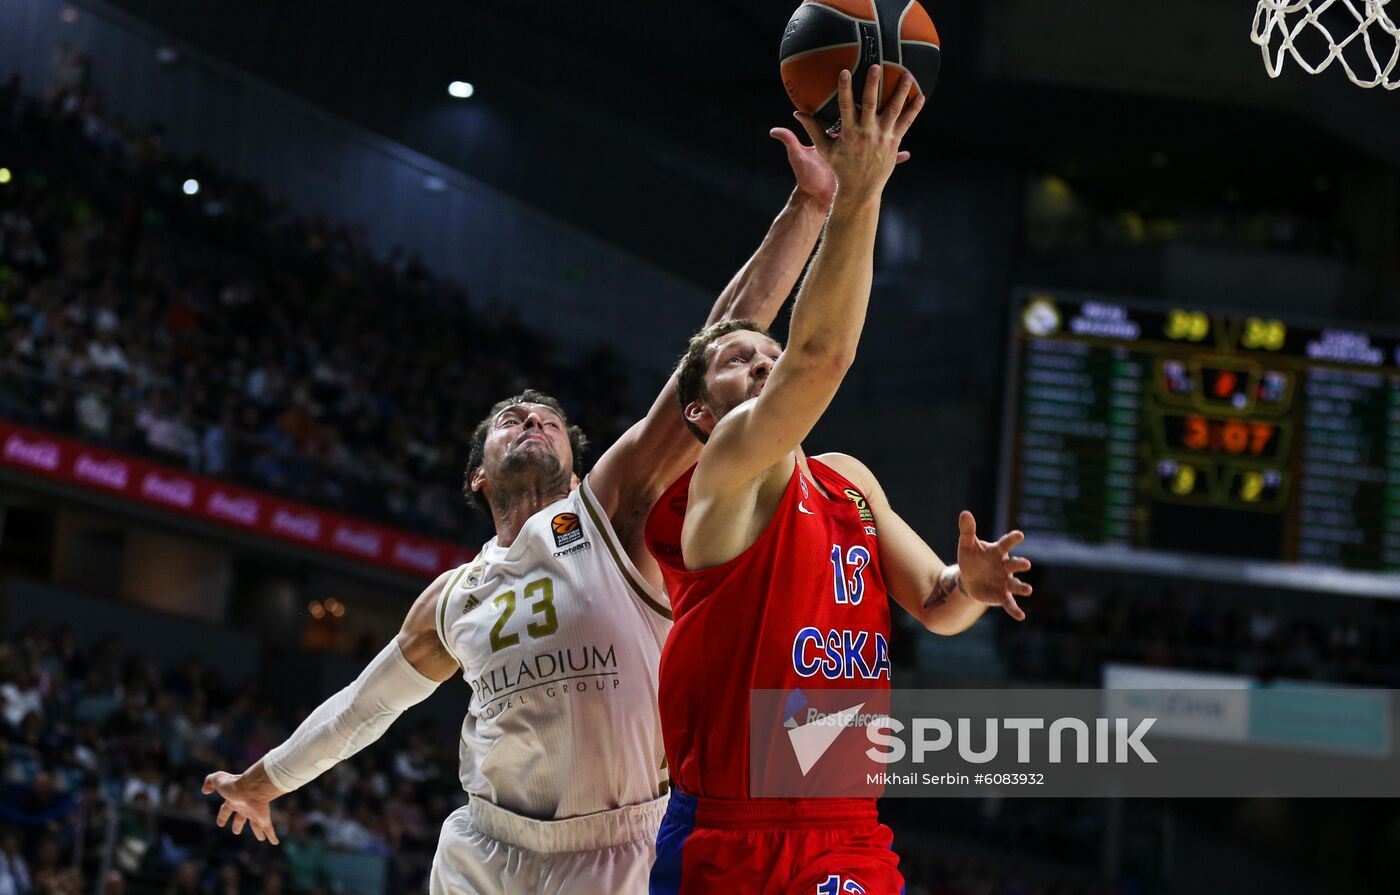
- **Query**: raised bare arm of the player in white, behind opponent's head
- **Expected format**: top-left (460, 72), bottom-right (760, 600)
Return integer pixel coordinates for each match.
top-left (589, 127), bottom-right (836, 524)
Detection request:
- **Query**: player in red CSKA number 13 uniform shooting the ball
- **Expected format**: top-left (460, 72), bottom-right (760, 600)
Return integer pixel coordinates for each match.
top-left (647, 69), bottom-right (1030, 895)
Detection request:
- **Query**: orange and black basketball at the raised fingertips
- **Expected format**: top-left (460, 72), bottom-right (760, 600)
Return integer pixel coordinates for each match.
top-left (778, 0), bottom-right (941, 126)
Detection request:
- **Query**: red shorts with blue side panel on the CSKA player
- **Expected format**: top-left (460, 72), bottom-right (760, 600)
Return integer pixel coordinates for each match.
top-left (651, 790), bottom-right (904, 895)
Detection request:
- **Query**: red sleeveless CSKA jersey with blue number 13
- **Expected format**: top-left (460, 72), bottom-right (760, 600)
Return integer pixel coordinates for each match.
top-left (645, 459), bottom-right (890, 800)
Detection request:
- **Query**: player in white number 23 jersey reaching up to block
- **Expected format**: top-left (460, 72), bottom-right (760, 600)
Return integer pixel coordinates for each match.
top-left (194, 129), bottom-right (862, 895)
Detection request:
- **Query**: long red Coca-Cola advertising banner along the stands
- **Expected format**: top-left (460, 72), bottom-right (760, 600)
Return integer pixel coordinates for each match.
top-left (0, 420), bottom-right (472, 577)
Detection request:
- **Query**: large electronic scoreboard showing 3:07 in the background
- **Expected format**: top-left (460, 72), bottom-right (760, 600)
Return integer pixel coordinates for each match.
top-left (1001, 293), bottom-right (1400, 597)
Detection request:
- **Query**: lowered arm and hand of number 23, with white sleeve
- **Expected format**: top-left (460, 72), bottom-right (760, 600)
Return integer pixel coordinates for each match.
top-left (204, 573), bottom-right (458, 845)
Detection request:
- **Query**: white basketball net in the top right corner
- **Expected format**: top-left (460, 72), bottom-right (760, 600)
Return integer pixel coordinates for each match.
top-left (1250, 0), bottom-right (1400, 90)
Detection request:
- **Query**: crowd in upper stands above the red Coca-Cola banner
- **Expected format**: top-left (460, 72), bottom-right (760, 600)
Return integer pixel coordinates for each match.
top-left (0, 64), bottom-right (629, 542)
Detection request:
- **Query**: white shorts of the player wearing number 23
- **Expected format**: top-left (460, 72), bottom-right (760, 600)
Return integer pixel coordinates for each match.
top-left (428, 798), bottom-right (666, 895)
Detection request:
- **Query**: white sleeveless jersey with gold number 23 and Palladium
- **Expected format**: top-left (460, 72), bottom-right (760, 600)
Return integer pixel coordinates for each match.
top-left (437, 479), bottom-right (671, 819)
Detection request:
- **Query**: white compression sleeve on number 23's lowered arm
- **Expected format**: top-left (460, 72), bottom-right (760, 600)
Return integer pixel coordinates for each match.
top-left (263, 640), bottom-right (438, 793)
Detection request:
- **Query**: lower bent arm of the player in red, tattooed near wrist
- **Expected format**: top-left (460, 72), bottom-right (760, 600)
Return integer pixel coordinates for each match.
top-left (819, 454), bottom-right (1030, 636)
